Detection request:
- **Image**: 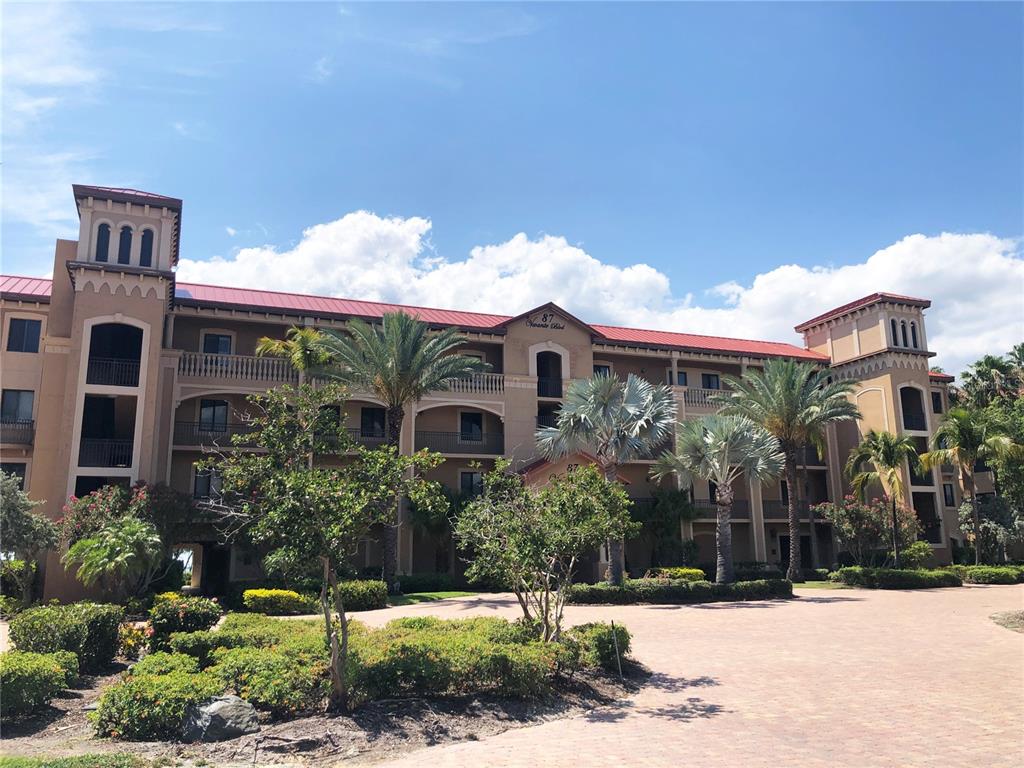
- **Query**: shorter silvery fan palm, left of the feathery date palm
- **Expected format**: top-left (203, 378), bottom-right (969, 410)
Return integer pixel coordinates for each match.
top-left (652, 414), bottom-right (785, 584)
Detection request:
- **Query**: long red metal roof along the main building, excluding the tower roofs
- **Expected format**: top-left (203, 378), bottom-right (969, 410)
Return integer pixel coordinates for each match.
top-left (0, 276), bottom-right (828, 362)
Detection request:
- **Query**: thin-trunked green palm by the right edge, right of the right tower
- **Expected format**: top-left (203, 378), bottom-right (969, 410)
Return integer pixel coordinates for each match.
top-left (921, 408), bottom-right (1024, 565)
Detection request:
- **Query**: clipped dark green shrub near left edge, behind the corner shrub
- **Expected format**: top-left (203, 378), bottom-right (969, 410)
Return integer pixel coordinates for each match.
top-left (10, 602), bottom-right (124, 672)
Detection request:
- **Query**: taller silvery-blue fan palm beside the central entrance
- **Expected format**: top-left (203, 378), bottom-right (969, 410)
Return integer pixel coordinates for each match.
top-left (537, 374), bottom-right (676, 586)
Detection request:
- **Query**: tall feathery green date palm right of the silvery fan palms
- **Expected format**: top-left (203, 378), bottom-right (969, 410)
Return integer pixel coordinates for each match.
top-left (715, 359), bottom-right (860, 582)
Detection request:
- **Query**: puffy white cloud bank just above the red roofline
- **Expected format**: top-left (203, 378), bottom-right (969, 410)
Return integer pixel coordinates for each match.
top-left (178, 211), bottom-right (1024, 372)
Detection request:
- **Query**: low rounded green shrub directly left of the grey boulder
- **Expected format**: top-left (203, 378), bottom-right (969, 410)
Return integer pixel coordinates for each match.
top-left (92, 672), bottom-right (224, 741)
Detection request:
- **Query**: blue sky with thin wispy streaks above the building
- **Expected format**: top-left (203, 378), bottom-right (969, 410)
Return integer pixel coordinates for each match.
top-left (3, 3), bottom-right (1024, 372)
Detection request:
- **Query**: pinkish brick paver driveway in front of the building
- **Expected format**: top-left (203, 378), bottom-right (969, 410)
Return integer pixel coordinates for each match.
top-left (359, 586), bottom-right (1024, 768)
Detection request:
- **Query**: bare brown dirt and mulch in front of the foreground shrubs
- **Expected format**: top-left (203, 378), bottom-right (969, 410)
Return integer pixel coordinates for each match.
top-left (0, 665), bottom-right (649, 766)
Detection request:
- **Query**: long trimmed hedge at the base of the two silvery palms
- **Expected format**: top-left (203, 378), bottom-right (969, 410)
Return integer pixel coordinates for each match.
top-left (567, 579), bottom-right (793, 605)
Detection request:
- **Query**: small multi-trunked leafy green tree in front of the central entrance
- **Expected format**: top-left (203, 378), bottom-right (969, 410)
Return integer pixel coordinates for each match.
top-left (455, 461), bottom-right (639, 641)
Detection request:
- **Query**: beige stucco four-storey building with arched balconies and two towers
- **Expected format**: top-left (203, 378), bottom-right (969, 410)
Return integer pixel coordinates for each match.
top-left (0, 185), bottom-right (961, 598)
